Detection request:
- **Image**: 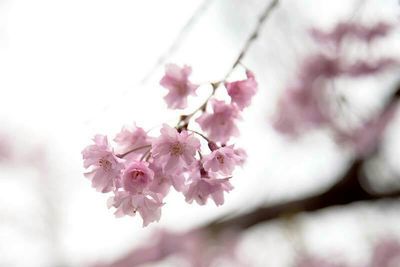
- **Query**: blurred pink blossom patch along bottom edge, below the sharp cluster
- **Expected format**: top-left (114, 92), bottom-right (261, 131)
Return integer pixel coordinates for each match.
top-left (92, 229), bottom-right (244, 267)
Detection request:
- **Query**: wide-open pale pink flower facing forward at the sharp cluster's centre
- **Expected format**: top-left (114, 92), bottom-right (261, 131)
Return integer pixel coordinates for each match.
top-left (151, 124), bottom-right (200, 173)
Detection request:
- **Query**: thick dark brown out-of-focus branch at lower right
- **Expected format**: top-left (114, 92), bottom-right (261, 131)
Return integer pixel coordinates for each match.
top-left (203, 86), bottom-right (400, 233)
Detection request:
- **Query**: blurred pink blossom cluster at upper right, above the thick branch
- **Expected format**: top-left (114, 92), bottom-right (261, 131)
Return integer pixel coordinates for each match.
top-left (274, 23), bottom-right (399, 156)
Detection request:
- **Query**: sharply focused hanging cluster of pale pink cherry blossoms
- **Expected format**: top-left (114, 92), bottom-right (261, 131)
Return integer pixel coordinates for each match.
top-left (82, 64), bottom-right (257, 226)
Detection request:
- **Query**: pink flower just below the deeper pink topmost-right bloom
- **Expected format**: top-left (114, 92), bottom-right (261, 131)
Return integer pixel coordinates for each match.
top-left (196, 100), bottom-right (240, 143)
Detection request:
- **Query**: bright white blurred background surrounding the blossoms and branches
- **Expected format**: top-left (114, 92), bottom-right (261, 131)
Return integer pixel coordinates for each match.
top-left (0, 0), bottom-right (400, 267)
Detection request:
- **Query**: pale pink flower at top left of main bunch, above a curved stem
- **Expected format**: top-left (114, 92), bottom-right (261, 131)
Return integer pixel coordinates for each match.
top-left (114, 124), bottom-right (151, 159)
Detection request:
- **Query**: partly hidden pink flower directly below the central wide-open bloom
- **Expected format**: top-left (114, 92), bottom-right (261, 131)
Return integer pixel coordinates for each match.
top-left (149, 163), bottom-right (185, 197)
